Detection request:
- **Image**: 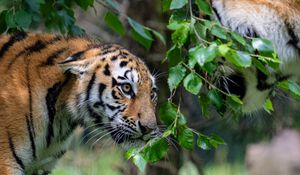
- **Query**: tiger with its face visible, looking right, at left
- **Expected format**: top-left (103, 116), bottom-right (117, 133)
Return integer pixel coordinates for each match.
top-left (0, 32), bottom-right (158, 175)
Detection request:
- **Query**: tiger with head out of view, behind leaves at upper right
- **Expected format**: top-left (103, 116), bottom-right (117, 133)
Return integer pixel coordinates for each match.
top-left (210, 0), bottom-right (300, 113)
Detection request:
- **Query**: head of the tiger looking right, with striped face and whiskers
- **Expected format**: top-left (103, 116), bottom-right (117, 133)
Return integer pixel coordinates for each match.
top-left (60, 45), bottom-right (158, 148)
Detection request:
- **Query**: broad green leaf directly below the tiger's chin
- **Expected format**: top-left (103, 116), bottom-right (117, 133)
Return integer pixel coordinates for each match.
top-left (142, 138), bottom-right (169, 162)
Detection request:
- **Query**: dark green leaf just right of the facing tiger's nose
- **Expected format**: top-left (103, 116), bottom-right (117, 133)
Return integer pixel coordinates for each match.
top-left (159, 102), bottom-right (178, 125)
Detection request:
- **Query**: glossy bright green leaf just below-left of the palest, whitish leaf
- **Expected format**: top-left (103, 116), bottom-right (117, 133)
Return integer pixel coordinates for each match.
top-left (225, 50), bottom-right (252, 68)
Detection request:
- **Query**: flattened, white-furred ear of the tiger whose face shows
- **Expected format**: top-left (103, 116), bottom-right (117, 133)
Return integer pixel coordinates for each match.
top-left (58, 57), bottom-right (91, 77)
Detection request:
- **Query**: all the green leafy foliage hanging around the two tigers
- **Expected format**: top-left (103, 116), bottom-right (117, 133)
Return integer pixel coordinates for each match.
top-left (0, 0), bottom-right (300, 171)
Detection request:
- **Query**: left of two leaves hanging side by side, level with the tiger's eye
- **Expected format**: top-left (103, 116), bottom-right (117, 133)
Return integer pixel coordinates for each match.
top-left (168, 64), bottom-right (186, 92)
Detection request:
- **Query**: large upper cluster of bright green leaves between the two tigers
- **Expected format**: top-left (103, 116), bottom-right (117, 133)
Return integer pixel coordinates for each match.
top-left (163, 0), bottom-right (280, 116)
